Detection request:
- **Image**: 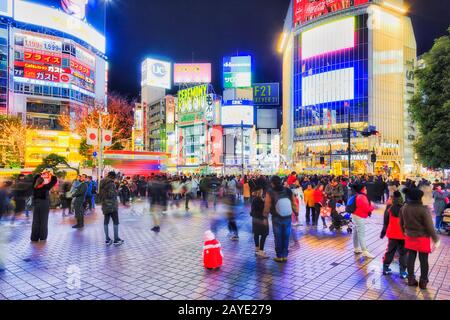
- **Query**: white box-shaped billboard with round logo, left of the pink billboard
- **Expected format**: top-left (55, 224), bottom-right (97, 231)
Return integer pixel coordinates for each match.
top-left (142, 58), bottom-right (172, 89)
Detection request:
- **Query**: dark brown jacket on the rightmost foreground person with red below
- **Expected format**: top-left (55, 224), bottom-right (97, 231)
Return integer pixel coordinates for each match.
top-left (400, 201), bottom-right (438, 242)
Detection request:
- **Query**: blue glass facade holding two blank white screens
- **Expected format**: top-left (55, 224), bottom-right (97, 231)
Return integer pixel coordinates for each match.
top-left (293, 14), bottom-right (369, 141)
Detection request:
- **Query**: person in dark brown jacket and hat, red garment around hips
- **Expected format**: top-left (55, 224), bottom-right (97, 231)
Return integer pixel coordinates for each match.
top-left (400, 188), bottom-right (440, 289)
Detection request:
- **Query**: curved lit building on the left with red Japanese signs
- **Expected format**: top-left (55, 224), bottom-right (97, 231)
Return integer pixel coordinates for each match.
top-left (0, 0), bottom-right (107, 167)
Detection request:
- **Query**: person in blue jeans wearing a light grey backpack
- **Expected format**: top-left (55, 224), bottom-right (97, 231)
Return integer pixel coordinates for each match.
top-left (264, 176), bottom-right (298, 262)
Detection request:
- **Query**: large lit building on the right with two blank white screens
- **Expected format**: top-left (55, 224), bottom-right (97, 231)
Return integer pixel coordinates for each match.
top-left (279, 0), bottom-right (416, 175)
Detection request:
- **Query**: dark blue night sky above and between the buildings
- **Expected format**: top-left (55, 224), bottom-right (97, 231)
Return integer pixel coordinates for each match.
top-left (106, 0), bottom-right (450, 98)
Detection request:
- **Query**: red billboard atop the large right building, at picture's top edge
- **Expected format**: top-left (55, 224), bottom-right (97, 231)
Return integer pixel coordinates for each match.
top-left (293, 0), bottom-right (370, 25)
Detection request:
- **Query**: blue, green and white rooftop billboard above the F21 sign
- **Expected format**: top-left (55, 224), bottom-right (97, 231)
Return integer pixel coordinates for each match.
top-left (223, 56), bottom-right (252, 89)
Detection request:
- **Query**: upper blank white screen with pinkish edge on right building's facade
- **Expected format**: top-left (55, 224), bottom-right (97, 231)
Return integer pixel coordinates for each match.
top-left (302, 17), bottom-right (355, 59)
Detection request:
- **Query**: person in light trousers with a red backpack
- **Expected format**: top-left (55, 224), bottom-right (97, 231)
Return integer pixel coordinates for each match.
top-left (346, 184), bottom-right (375, 259)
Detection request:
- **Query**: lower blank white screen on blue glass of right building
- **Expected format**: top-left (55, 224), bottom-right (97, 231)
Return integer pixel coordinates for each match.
top-left (302, 68), bottom-right (355, 106)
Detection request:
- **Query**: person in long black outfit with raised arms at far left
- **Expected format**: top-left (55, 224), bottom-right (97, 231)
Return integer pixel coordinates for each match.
top-left (31, 169), bottom-right (58, 242)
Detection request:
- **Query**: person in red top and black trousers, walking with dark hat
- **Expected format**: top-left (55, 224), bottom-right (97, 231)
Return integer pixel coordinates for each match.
top-left (380, 191), bottom-right (408, 279)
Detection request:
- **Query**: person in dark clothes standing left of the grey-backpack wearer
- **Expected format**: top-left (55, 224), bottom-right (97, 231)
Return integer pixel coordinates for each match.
top-left (250, 187), bottom-right (269, 259)
